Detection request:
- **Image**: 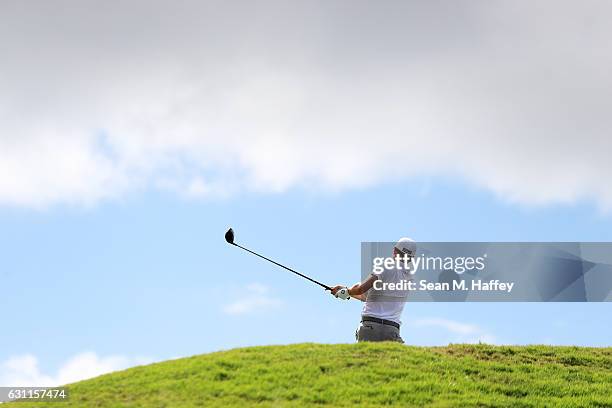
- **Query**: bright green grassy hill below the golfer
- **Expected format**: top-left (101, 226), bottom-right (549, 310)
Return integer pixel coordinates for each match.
top-left (3, 343), bottom-right (612, 408)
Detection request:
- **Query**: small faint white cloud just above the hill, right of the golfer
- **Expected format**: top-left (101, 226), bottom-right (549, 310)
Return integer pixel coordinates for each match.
top-left (407, 317), bottom-right (499, 344)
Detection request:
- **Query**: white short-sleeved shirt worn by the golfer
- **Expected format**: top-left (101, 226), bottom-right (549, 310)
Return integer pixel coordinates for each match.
top-left (361, 265), bottom-right (412, 324)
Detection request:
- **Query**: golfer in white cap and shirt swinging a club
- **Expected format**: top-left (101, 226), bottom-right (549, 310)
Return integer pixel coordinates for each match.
top-left (332, 238), bottom-right (416, 343)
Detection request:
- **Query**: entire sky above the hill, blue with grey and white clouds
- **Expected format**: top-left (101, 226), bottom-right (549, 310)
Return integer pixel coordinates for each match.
top-left (0, 1), bottom-right (612, 385)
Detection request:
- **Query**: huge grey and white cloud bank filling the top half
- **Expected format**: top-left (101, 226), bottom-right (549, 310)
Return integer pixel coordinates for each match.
top-left (0, 1), bottom-right (612, 208)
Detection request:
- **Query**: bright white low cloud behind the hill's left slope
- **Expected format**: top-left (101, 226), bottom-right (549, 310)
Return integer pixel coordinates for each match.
top-left (0, 352), bottom-right (152, 387)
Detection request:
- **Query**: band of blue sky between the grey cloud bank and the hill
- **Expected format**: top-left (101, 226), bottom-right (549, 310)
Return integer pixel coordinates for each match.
top-left (0, 179), bottom-right (612, 384)
